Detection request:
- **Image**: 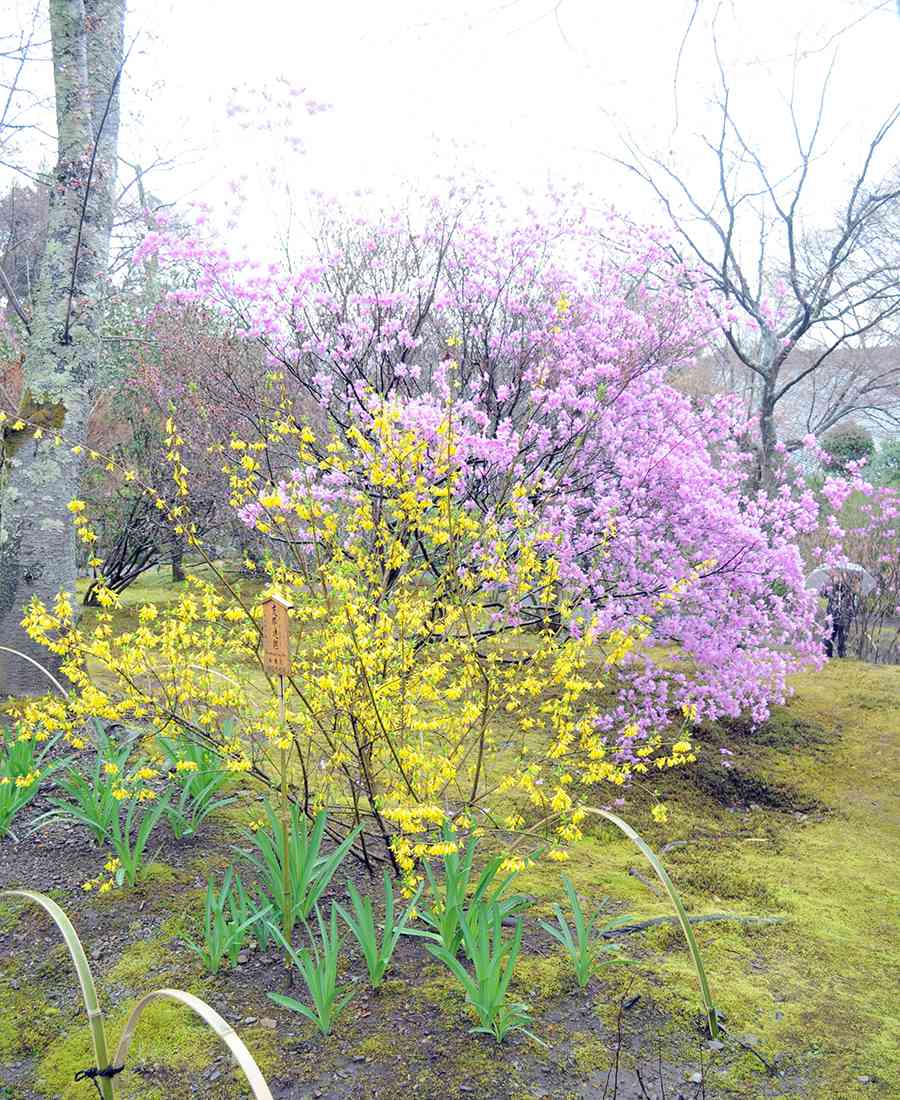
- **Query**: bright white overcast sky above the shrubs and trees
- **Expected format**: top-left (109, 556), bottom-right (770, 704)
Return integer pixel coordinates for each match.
top-left (6, 0), bottom-right (900, 251)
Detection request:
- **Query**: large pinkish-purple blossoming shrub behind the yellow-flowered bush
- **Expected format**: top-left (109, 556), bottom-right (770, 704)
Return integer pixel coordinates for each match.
top-left (134, 197), bottom-right (836, 759)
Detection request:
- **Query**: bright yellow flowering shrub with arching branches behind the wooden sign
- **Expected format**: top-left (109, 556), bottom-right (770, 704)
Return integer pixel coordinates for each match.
top-left (17, 400), bottom-right (693, 875)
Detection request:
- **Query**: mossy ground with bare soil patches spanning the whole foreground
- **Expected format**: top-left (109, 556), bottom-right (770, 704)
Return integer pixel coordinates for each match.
top-left (0, 578), bottom-right (900, 1100)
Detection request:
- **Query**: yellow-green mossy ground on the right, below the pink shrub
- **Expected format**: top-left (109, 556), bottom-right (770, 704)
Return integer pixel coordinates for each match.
top-left (529, 662), bottom-right (900, 1100)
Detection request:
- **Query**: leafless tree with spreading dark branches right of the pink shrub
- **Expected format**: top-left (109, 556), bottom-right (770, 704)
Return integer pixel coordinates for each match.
top-left (614, 41), bottom-right (900, 484)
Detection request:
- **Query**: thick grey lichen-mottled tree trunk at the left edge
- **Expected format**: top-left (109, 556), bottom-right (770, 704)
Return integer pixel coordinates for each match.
top-left (0, 0), bottom-right (125, 695)
